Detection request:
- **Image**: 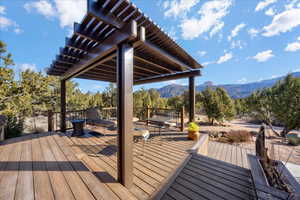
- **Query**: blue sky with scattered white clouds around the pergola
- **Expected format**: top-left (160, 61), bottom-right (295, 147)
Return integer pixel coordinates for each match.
top-left (0, 0), bottom-right (300, 92)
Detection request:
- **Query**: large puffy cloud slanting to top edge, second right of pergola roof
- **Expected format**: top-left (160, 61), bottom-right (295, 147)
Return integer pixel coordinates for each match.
top-left (180, 0), bottom-right (232, 40)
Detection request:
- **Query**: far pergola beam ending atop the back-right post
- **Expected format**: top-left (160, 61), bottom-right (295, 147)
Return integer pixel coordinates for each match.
top-left (134, 70), bottom-right (201, 85)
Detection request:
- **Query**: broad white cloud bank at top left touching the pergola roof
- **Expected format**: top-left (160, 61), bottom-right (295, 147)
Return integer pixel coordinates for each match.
top-left (24, 0), bottom-right (87, 28)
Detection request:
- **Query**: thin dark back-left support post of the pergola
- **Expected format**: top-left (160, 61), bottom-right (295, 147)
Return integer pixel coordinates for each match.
top-left (60, 80), bottom-right (66, 133)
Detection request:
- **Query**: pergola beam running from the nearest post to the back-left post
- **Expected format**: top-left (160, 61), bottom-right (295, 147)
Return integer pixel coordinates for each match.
top-left (61, 21), bottom-right (137, 79)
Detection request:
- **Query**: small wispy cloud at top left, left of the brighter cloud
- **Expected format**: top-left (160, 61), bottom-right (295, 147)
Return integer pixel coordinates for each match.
top-left (24, 0), bottom-right (56, 18)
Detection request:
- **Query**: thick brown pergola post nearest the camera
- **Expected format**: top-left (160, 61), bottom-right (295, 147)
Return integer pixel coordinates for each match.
top-left (117, 43), bottom-right (134, 188)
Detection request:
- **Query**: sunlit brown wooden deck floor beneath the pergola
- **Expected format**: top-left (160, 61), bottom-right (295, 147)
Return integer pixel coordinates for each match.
top-left (0, 131), bottom-right (193, 200)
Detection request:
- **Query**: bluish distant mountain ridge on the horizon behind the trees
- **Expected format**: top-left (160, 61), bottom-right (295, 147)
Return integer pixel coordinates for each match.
top-left (157, 72), bottom-right (300, 98)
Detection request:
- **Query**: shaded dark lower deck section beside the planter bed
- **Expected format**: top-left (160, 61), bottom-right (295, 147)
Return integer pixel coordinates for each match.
top-left (162, 154), bottom-right (256, 200)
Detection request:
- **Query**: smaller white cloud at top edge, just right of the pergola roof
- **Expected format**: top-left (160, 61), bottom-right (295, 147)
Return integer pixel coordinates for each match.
top-left (163, 0), bottom-right (199, 17)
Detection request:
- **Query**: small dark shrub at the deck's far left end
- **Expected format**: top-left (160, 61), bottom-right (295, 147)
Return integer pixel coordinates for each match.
top-left (4, 115), bottom-right (23, 138)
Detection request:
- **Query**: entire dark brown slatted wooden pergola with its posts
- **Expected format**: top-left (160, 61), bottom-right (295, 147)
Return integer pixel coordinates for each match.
top-left (47, 0), bottom-right (202, 188)
